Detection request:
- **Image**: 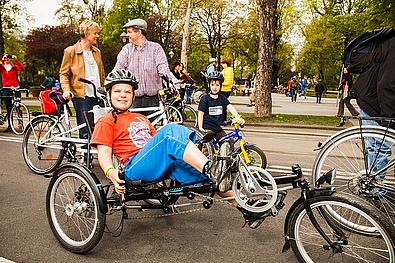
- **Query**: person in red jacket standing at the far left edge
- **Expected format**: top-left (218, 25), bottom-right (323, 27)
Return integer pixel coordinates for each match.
top-left (0, 54), bottom-right (25, 132)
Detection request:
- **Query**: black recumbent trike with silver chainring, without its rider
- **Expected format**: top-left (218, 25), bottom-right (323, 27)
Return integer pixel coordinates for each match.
top-left (46, 132), bottom-right (395, 262)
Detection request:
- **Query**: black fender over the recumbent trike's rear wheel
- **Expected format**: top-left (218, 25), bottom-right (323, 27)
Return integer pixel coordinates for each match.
top-left (54, 163), bottom-right (108, 213)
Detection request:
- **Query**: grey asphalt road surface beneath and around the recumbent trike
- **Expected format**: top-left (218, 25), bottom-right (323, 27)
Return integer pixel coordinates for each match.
top-left (0, 129), bottom-right (330, 263)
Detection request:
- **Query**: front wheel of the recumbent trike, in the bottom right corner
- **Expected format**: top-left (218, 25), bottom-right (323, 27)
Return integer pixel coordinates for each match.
top-left (286, 194), bottom-right (395, 263)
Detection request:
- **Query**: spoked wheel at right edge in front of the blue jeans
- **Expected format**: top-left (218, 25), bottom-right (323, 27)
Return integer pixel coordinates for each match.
top-left (313, 126), bottom-right (395, 223)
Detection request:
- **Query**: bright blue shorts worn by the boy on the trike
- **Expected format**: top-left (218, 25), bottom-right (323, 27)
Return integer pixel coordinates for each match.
top-left (125, 123), bottom-right (208, 184)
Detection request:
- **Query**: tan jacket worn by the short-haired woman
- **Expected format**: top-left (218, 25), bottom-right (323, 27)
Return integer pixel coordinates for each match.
top-left (59, 41), bottom-right (105, 98)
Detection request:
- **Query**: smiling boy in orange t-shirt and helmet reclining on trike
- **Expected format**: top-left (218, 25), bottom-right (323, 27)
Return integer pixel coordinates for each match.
top-left (91, 69), bottom-right (263, 228)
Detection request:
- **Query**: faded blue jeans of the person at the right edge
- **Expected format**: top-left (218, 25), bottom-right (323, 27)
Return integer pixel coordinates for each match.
top-left (359, 110), bottom-right (392, 179)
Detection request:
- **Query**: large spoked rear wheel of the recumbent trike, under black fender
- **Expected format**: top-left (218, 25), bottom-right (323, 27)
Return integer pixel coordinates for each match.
top-left (46, 167), bottom-right (106, 253)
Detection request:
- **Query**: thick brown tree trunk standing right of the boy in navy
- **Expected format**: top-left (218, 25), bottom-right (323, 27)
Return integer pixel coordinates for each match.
top-left (255, 0), bottom-right (278, 117)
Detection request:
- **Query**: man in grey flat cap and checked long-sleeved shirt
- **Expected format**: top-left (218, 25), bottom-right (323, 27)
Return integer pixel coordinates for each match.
top-left (114, 18), bottom-right (178, 108)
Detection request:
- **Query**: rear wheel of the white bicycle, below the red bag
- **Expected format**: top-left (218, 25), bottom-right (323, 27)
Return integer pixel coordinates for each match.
top-left (22, 116), bottom-right (64, 174)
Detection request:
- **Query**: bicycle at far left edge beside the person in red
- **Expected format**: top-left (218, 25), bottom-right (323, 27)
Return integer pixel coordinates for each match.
top-left (0, 89), bottom-right (30, 135)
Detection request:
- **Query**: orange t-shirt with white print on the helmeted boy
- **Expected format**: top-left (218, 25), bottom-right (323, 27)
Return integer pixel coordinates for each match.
top-left (91, 112), bottom-right (156, 162)
